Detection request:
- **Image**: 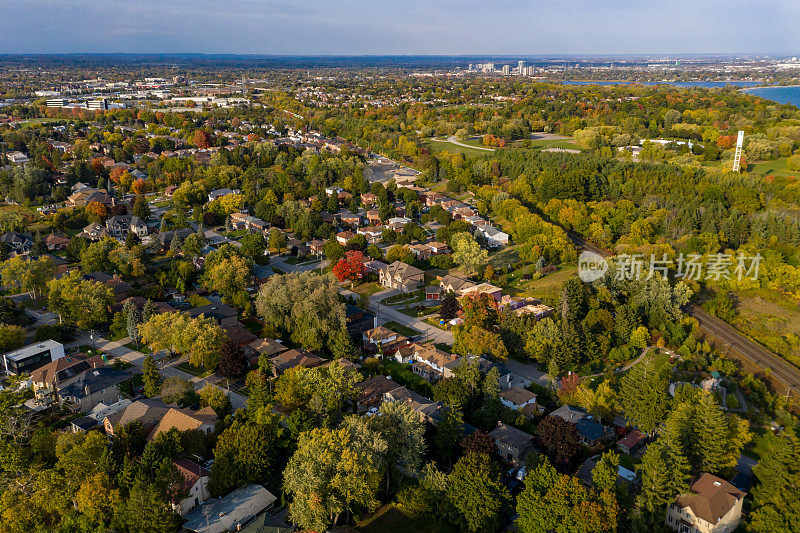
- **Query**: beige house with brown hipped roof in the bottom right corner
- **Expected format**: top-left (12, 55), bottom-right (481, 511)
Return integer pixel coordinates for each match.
top-left (666, 473), bottom-right (745, 533)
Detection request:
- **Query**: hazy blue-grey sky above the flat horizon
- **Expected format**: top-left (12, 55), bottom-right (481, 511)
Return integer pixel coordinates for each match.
top-left (0, 0), bottom-right (800, 55)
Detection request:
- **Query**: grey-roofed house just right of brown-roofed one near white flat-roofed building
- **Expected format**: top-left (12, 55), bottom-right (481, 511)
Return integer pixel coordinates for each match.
top-left (55, 366), bottom-right (131, 413)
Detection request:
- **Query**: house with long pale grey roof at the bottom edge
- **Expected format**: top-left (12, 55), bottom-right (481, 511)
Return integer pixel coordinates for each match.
top-left (183, 484), bottom-right (278, 533)
